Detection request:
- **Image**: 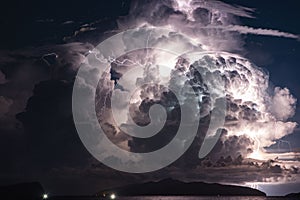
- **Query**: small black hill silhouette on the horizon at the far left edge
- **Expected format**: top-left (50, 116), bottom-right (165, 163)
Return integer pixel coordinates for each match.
top-left (0, 182), bottom-right (44, 200)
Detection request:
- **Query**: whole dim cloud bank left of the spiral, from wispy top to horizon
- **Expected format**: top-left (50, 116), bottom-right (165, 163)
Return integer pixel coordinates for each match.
top-left (0, 43), bottom-right (92, 190)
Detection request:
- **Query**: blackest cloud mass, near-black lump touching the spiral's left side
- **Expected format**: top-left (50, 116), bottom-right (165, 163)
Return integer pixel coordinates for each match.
top-left (17, 80), bottom-right (89, 174)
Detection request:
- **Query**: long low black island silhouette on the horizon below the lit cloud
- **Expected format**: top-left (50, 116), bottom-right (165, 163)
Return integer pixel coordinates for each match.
top-left (97, 179), bottom-right (266, 196)
